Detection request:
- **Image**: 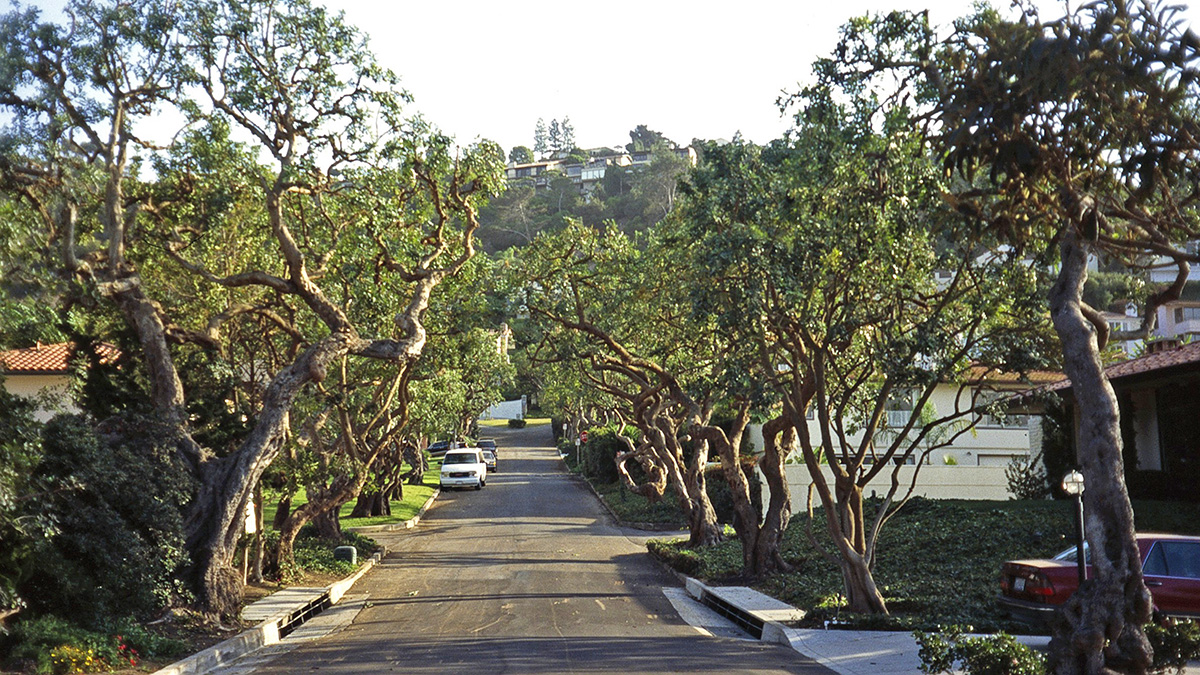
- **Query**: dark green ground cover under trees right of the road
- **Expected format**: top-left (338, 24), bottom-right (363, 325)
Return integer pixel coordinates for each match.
top-left (649, 500), bottom-right (1200, 632)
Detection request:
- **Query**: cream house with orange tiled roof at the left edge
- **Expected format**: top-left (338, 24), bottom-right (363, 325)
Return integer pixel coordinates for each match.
top-left (0, 342), bottom-right (118, 422)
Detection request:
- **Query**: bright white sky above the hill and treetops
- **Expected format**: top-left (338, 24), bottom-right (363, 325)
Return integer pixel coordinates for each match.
top-left (26, 0), bottom-right (1200, 153)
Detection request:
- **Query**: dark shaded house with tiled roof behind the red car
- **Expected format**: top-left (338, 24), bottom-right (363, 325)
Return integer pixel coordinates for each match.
top-left (1046, 342), bottom-right (1200, 501)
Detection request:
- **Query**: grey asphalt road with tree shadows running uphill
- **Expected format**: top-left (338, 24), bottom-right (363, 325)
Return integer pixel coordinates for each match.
top-left (250, 426), bottom-right (832, 675)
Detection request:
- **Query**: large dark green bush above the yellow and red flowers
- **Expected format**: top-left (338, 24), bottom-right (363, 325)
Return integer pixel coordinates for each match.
top-left (20, 416), bottom-right (192, 627)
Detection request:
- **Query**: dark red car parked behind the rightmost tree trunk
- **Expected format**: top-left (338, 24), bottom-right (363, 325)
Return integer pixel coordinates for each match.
top-left (998, 533), bottom-right (1200, 623)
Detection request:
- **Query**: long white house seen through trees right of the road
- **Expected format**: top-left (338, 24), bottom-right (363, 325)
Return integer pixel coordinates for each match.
top-left (748, 369), bottom-right (1062, 504)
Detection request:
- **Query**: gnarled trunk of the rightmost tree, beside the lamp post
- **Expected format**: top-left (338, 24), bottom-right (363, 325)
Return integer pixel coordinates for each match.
top-left (1050, 228), bottom-right (1152, 675)
